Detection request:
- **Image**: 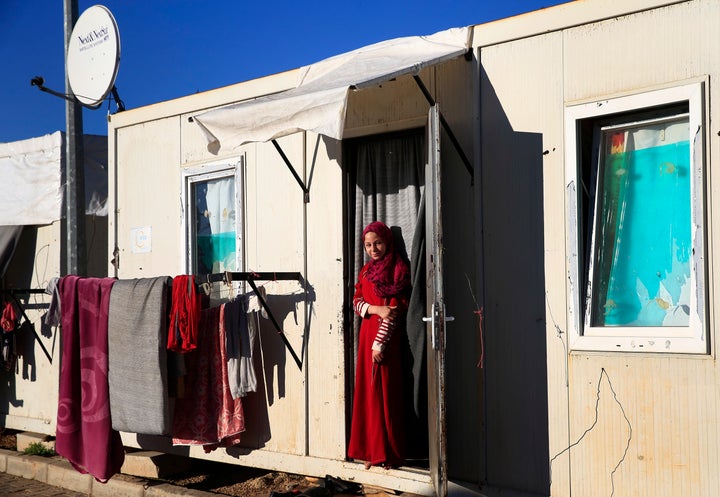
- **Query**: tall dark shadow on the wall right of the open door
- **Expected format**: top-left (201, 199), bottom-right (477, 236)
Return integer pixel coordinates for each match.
top-left (480, 67), bottom-right (562, 495)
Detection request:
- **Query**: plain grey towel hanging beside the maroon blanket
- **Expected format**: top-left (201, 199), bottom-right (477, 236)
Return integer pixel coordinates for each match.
top-left (108, 276), bottom-right (171, 435)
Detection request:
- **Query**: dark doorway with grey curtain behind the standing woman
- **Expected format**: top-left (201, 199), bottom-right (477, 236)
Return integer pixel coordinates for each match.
top-left (343, 128), bottom-right (428, 469)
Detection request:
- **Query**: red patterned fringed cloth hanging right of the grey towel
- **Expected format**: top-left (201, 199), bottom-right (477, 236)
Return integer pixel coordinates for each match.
top-left (172, 305), bottom-right (245, 452)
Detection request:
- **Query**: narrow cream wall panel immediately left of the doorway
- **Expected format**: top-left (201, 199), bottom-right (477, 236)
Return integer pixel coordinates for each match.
top-left (306, 134), bottom-right (347, 460)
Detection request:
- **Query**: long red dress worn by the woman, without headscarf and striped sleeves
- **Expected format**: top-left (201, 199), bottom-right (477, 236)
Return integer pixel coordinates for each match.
top-left (348, 265), bottom-right (407, 466)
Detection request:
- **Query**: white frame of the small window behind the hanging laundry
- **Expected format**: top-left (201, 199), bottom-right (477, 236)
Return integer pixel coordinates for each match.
top-left (182, 155), bottom-right (245, 274)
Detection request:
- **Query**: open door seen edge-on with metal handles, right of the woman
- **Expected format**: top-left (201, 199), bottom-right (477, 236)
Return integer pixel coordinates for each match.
top-left (423, 105), bottom-right (452, 497)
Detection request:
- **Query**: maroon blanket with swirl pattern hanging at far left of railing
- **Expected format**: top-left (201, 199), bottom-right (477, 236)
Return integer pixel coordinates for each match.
top-left (55, 276), bottom-right (125, 483)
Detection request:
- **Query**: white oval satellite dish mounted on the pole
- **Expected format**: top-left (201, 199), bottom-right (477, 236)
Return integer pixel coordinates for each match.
top-left (66, 5), bottom-right (120, 107)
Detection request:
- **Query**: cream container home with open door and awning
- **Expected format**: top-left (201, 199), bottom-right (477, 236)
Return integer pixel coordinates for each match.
top-left (2, 0), bottom-right (720, 497)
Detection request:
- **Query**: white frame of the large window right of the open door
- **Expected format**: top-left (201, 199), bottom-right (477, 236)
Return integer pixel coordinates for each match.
top-left (565, 82), bottom-right (710, 354)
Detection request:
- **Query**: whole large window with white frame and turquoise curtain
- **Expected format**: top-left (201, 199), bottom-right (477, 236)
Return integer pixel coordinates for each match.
top-left (565, 83), bottom-right (710, 354)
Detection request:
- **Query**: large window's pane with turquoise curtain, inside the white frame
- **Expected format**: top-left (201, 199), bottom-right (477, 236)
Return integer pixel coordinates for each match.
top-left (591, 116), bottom-right (692, 326)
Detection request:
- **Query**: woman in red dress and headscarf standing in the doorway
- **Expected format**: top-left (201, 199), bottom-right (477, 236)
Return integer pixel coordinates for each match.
top-left (348, 221), bottom-right (410, 469)
